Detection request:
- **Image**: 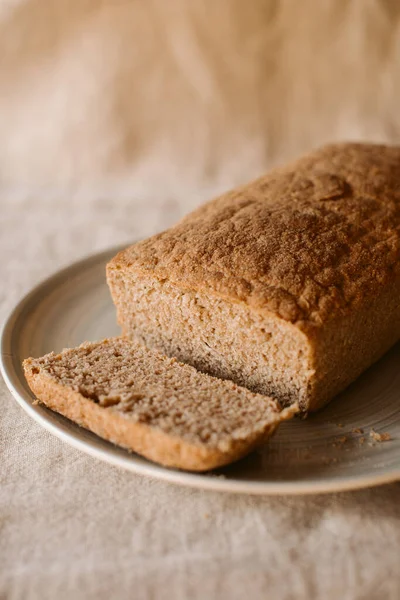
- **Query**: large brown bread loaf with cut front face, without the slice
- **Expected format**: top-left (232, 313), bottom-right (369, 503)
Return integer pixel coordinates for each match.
top-left (107, 144), bottom-right (400, 411)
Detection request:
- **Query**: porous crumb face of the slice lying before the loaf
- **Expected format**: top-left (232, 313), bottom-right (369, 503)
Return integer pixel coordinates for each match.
top-left (24, 338), bottom-right (284, 450)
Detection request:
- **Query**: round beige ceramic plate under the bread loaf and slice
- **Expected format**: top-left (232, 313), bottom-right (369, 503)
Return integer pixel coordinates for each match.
top-left (1, 248), bottom-right (400, 494)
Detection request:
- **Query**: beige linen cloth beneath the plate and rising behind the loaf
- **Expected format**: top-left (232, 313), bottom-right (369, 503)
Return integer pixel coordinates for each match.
top-left (0, 0), bottom-right (400, 600)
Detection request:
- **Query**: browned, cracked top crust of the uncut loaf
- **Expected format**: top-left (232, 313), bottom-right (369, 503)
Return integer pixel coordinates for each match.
top-left (110, 143), bottom-right (400, 325)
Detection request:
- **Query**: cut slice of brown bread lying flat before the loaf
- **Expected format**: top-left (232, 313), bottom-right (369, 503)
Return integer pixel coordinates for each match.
top-left (23, 338), bottom-right (296, 471)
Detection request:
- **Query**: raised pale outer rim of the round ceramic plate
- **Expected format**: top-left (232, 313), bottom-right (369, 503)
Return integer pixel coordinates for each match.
top-left (0, 246), bottom-right (400, 496)
